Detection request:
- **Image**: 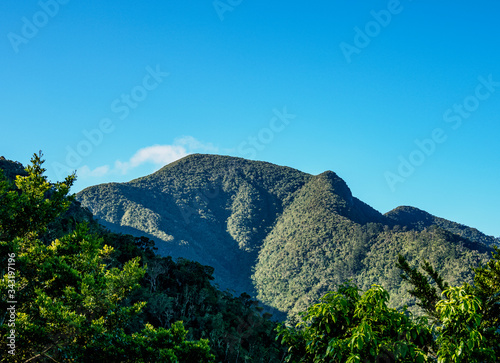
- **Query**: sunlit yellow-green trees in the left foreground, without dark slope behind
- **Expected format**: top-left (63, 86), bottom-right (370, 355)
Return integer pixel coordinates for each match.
top-left (0, 154), bottom-right (214, 362)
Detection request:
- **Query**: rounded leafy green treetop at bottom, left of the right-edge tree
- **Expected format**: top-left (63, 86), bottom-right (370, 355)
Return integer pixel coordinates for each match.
top-left (279, 284), bottom-right (432, 363)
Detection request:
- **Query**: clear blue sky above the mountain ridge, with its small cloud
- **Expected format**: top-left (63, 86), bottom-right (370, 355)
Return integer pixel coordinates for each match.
top-left (0, 0), bottom-right (500, 236)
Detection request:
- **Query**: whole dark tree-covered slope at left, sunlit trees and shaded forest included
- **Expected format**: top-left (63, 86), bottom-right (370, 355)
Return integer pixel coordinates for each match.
top-left (0, 155), bottom-right (284, 363)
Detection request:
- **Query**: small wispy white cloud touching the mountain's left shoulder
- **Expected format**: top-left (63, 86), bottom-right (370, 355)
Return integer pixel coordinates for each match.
top-left (78, 136), bottom-right (218, 178)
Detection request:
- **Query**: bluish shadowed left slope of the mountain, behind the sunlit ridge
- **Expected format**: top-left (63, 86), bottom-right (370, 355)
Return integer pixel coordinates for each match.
top-left (77, 155), bottom-right (310, 292)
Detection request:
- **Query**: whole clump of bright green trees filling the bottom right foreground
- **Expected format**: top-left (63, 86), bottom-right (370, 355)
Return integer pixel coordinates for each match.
top-left (278, 253), bottom-right (500, 363)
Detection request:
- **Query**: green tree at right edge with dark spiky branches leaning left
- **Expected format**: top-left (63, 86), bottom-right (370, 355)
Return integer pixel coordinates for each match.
top-left (398, 255), bottom-right (500, 362)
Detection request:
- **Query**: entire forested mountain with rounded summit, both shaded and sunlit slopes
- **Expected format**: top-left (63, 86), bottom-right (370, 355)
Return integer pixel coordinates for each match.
top-left (77, 154), bottom-right (494, 314)
